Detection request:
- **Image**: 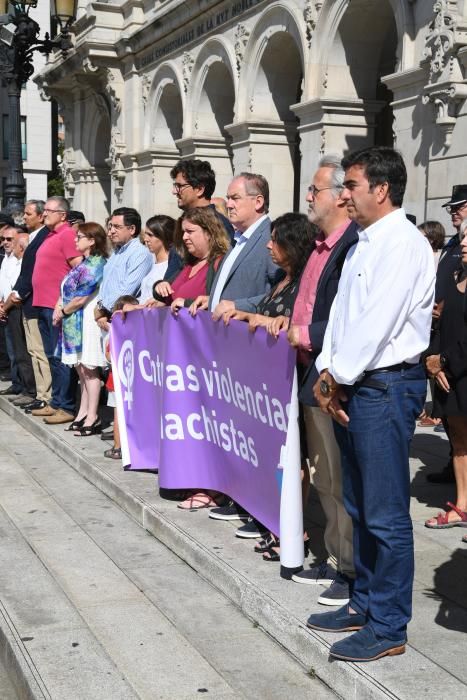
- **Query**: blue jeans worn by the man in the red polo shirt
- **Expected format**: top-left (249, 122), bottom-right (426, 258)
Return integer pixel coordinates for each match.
top-left (38, 306), bottom-right (76, 413)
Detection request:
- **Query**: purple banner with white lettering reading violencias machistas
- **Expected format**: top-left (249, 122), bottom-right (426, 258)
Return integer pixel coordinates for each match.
top-left (111, 309), bottom-right (295, 534)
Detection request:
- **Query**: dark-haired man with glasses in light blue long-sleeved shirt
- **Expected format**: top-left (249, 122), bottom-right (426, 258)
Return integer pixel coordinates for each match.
top-left (94, 207), bottom-right (154, 331)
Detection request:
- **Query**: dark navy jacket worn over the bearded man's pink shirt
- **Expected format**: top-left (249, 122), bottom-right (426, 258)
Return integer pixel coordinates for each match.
top-left (298, 221), bottom-right (358, 406)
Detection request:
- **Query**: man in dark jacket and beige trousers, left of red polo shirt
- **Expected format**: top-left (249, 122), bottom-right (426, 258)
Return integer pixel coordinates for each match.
top-left (0, 199), bottom-right (52, 413)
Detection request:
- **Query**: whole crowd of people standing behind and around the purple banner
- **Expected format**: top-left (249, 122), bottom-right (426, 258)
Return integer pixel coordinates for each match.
top-left (0, 147), bottom-right (467, 661)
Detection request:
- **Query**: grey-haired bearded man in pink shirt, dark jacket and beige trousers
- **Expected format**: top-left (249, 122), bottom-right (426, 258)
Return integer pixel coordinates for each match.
top-left (282, 155), bottom-right (358, 606)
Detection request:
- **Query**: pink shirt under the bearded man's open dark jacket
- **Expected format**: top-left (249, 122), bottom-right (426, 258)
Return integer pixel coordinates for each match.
top-left (291, 220), bottom-right (350, 361)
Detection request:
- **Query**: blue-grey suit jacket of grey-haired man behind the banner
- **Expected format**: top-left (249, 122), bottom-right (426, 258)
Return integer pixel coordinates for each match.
top-left (209, 217), bottom-right (284, 313)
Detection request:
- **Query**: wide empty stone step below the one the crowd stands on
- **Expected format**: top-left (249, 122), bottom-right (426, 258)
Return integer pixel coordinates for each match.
top-left (0, 415), bottom-right (334, 700)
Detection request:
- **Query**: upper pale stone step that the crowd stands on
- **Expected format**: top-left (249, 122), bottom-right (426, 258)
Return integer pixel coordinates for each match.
top-left (0, 399), bottom-right (467, 700)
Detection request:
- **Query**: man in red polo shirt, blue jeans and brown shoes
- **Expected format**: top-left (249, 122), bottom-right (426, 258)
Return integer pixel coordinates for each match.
top-left (31, 196), bottom-right (82, 424)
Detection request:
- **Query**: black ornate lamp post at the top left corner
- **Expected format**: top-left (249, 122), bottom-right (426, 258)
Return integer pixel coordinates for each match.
top-left (0, 0), bottom-right (77, 212)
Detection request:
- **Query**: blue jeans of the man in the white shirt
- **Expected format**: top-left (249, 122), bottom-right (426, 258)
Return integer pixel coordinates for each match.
top-left (335, 365), bottom-right (426, 641)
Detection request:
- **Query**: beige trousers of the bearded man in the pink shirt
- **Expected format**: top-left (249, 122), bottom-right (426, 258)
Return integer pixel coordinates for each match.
top-left (303, 406), bottom-right (355, 578)
